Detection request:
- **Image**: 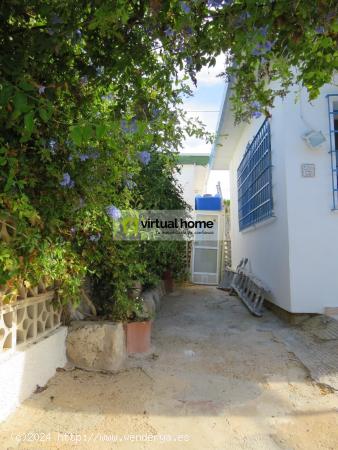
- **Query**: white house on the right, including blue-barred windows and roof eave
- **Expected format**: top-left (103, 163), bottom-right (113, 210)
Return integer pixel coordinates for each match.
top-left (211, 78), bottom-right (338, 314)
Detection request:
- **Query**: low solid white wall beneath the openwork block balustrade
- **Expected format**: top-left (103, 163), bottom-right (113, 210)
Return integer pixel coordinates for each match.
top-left (0, 327), bottom-right (67, 422)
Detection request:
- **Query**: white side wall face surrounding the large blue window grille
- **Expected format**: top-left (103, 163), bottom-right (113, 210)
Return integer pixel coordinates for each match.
top-left (230, 103), bottom-right (291, 310)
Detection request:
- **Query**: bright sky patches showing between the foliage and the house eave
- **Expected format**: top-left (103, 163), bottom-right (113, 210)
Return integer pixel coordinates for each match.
top-left (181, 56), bottom-right (229, 198)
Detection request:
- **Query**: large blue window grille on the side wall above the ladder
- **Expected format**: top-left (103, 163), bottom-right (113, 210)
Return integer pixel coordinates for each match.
top-left (237, 120), bottom-right (273, 230)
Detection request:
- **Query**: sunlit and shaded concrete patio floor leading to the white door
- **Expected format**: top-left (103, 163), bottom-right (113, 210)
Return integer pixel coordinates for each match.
top-left (0, 286), bottom-right (338, 450)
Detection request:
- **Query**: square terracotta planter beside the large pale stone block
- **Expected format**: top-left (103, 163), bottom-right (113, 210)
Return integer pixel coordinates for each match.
top-left (124, 320), bottom-right (152, 353)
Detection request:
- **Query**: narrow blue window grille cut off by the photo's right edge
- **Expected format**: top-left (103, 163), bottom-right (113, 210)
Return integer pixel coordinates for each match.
top-left (327, 94), bottom-right (338, 210)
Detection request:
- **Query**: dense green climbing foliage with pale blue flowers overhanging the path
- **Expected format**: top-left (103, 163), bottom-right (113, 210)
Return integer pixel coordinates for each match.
top-left (0, 0), bottom-right (337, 316)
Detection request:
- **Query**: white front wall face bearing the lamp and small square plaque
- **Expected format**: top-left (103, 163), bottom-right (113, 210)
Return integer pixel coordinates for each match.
top-left (282, 85), bottom-right (338, 313)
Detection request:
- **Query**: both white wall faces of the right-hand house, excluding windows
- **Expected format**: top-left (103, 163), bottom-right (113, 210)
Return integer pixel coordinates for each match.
top-left (225, 81), bottom-right (338, 313)
